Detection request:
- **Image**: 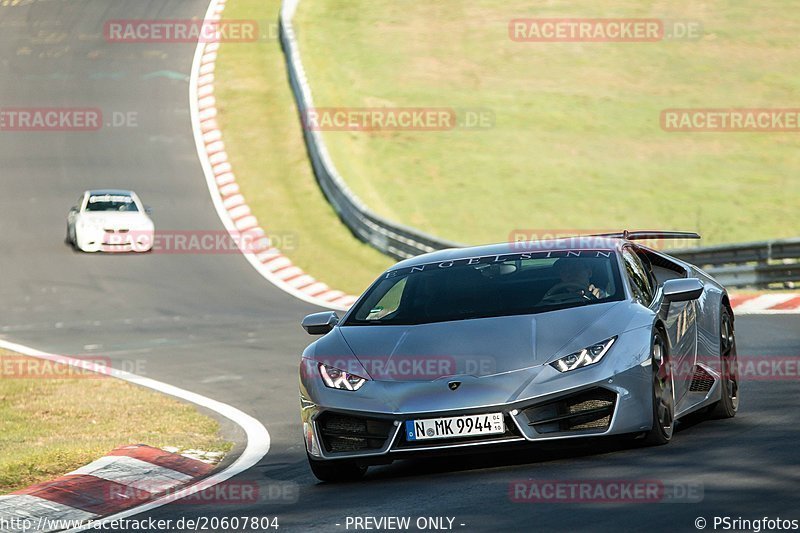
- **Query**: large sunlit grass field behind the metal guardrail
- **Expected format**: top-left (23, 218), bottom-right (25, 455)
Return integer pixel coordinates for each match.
top-left (294, 0), bottom-right (800, 246)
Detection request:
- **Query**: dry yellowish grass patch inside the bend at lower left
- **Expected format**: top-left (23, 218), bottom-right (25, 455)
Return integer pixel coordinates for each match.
top-left (0, 350), bottom-right (231, 494)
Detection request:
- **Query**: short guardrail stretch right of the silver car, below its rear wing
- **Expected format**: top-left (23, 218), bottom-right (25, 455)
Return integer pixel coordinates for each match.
top-left (666, 239), bottom-right (800, 288)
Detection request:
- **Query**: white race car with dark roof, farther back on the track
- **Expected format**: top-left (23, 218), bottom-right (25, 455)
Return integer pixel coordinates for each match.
top-left (67, 189), bottom-right (155, 252)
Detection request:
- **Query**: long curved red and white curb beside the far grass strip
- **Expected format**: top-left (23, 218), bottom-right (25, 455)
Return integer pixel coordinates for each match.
top-left (189, 0), bottom-right (356, 310)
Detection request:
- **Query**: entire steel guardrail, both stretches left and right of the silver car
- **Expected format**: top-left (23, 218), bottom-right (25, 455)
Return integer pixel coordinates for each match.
top-left (279, 0), bottom-right (800, 288)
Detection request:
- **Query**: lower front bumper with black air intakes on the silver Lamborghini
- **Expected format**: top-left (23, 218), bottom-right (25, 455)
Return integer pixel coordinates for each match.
top-left (301, 359), bottom-right (652, 464)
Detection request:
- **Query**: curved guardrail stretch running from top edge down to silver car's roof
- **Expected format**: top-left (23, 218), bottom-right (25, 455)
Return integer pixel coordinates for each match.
top-left (279, 0), bottom-right (460, 259)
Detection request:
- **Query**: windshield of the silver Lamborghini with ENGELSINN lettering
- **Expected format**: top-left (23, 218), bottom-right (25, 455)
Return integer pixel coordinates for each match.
top-left (343, 250), bottom-right (624, 326)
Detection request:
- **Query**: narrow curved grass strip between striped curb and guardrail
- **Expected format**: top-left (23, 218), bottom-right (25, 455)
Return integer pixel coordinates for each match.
top-left (215, 0), bottom-right (393, 294)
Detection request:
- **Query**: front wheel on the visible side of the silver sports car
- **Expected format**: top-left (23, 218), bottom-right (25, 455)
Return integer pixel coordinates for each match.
top-left (644, 329), bottom-right (675, 446)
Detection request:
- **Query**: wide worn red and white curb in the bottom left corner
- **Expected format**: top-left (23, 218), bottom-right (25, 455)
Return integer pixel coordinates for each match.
top-left (0, 444), bottom-right (214, 533)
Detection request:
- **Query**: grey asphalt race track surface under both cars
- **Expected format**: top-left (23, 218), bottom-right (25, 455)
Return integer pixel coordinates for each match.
top-left (0, 0), bottom-right (800, 531)
